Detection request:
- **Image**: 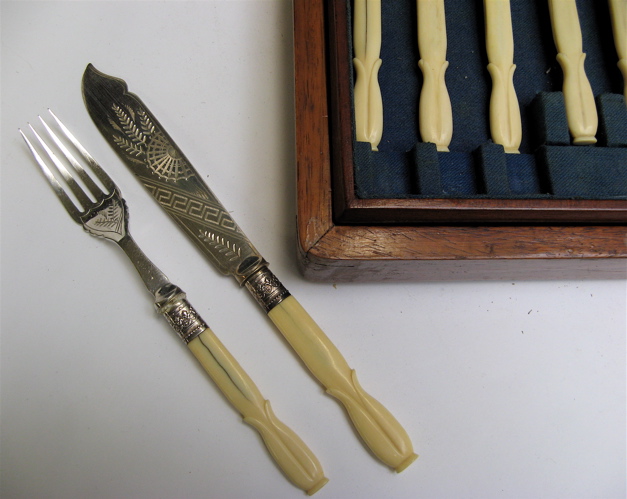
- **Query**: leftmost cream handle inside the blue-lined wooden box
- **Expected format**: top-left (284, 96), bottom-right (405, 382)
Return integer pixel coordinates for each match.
top-left (353, 0), bottom-right (383, 151)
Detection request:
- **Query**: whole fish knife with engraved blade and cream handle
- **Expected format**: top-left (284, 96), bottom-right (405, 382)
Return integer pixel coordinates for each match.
top-left (82, 64), bottom-right (418, 472)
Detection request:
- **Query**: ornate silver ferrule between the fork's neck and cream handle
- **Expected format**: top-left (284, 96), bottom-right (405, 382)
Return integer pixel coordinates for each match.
top-left (155, 283), bottom-right (208, 344)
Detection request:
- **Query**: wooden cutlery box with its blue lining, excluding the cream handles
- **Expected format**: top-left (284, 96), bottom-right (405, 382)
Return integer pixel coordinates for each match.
top-left (293, 0), bottom-right (627, 282)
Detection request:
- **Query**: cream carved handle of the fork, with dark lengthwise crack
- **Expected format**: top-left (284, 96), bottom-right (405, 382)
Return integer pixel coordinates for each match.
top-left (187, 329), bottom-right (328, 495)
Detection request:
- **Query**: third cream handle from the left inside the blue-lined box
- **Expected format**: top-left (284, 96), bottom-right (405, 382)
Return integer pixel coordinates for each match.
top-left (483, 0), bottom-right (522, 153)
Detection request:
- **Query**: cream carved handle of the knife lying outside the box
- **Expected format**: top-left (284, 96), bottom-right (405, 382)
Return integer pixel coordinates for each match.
top-left (268, 296), bottom-right (418, 472)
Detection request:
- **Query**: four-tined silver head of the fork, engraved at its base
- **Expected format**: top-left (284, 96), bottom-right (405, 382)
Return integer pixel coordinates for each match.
top-left (20, 110), bottom-right (128, 243)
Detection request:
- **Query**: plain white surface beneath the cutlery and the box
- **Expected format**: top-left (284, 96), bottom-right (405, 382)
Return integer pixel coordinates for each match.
top-left (0, 1), bottom-right (626, 499)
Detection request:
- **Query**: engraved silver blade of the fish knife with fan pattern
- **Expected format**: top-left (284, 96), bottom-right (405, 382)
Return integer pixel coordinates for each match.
top-left (82, 64), bottom-right (265, 283)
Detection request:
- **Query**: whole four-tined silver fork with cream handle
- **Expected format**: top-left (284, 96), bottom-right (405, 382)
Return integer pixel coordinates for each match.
top-left (19, 110), bottom-right (327, 495)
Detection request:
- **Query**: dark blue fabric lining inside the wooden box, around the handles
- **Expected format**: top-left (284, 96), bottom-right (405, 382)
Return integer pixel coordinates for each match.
top-left (347, 0), bottom-right (627, 199)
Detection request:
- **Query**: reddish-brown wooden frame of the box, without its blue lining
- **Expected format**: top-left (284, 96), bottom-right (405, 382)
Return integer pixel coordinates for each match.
top-left (294, 0), bottom-right (627, 282)
